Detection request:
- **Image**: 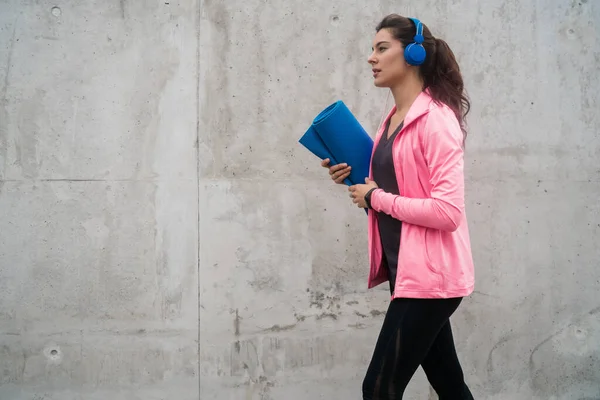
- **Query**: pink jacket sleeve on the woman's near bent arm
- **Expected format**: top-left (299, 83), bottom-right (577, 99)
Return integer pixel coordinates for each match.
top-left (371, 111), bottom-right (464, 232)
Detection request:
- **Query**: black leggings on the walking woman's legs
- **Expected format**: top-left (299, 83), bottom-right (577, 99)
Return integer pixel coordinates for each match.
top-left (362, 298), bottom-right (473, 400)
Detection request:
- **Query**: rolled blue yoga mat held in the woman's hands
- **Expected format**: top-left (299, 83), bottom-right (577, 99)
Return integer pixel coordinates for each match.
top-left (299, 101), bottom-right (373, 186)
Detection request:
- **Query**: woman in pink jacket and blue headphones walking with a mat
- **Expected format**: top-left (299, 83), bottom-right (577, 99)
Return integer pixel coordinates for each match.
top-left (322, 14), bottom-right (474, 400)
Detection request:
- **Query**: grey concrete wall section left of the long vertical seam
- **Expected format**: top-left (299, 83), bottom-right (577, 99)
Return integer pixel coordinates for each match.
top-left (0, 0), bottom-right (199, 400)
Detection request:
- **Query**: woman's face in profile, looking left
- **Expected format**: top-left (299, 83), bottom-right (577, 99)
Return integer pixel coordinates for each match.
top-left (368, 29), bottom-right (409, 87)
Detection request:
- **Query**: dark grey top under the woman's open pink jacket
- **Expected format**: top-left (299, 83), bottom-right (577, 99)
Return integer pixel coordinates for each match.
top-left (373, 120), bottom-right (404, 293)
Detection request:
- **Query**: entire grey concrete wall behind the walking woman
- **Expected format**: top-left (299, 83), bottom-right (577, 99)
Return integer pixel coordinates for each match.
top-left (0, 0), bottom-right (600, 400)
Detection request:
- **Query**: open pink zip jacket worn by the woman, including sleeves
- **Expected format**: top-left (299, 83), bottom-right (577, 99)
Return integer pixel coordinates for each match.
top-left (368, 91), bottom-right (475, 298)
